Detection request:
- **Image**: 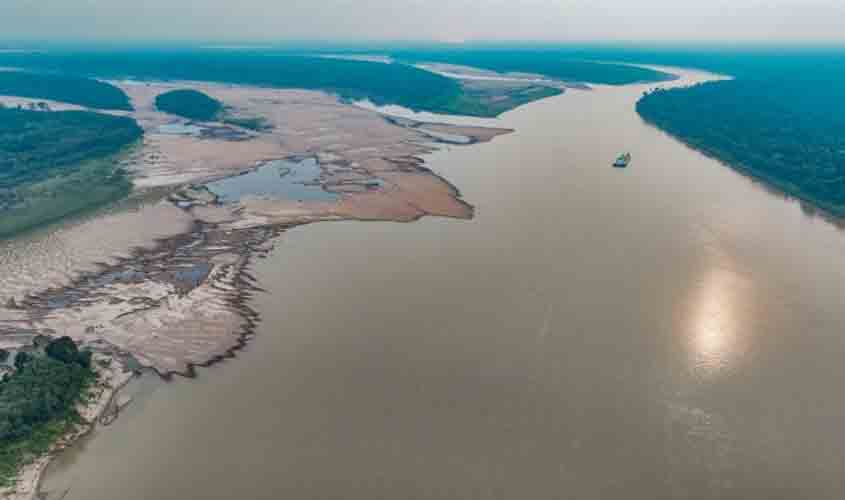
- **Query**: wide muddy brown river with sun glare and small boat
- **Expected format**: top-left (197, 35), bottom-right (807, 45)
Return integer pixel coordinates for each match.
top-left (44, 70), bottom-right (845, 500)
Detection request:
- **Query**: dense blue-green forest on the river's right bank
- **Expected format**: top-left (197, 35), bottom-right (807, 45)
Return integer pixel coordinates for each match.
top-left (637, 48), bottom-right (845, 215)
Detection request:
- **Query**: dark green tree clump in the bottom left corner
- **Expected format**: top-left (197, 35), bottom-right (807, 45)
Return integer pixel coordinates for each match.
top-left (0, 337), bottom-right (96, 486)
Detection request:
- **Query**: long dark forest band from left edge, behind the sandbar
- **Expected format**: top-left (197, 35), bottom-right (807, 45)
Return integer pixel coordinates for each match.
top-left (0, 50), bottom-right (462, 111)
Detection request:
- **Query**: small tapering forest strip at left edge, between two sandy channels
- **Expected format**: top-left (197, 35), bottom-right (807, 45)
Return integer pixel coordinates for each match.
top-left (0, 71), bottom-right (132, 111)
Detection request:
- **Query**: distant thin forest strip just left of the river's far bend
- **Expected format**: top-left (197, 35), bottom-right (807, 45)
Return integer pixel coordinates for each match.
top-left (390, 49), bottom-right (672, 85)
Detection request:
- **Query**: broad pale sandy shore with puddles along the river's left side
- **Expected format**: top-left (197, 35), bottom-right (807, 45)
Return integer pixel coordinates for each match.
top-left (0, 82), bottom-right (511, 500)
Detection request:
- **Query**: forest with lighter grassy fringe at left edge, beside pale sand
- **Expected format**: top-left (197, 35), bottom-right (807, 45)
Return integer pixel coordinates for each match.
top-left (0, 108), bottom-right (142, 236)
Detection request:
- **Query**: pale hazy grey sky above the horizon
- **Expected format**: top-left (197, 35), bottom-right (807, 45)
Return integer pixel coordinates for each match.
top-left (0, 0), bottom-right (845, 43)
